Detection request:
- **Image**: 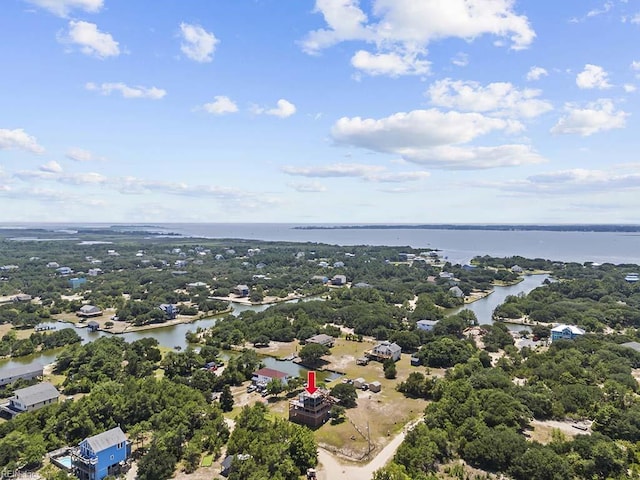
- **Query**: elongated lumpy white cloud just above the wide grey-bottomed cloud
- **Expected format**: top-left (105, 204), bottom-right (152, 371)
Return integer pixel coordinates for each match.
top-left (427, 78), bottom-right (553, 118)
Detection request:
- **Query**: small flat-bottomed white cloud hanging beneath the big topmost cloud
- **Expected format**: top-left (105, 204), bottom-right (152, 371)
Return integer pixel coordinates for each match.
top-left (351, 50), bottom-right (431, 77)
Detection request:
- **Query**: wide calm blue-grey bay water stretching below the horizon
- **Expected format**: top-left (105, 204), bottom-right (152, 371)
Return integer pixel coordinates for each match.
top-left (161, 223), bottom-right (640, 264)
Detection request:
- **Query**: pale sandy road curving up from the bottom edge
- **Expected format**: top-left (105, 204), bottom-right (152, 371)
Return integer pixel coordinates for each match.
top-left (318, 419), bottom-right (422, 480)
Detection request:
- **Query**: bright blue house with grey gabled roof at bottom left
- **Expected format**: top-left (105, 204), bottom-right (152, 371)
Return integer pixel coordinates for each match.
top-left (71, 427), bottom-right (131, 480)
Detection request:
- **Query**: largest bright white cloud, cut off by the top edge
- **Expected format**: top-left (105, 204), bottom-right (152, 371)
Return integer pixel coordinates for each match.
top-left (301, 0), bottom-right (535, 76)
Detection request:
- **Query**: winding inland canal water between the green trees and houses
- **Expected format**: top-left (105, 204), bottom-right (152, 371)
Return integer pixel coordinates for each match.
top-left (0, 275), bottom-right (548, 375)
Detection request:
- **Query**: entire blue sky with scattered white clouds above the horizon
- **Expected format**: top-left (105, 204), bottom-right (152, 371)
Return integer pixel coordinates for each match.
top-left (0, 0), bottom-right (640, 223)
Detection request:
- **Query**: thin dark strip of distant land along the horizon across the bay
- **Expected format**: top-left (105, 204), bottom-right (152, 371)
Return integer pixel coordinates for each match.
top-left (293, 224), bottom-right (640, 233)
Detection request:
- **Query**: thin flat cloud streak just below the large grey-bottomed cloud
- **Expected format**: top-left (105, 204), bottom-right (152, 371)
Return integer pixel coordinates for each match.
top-left (282, 163), bottom-right (430, 183)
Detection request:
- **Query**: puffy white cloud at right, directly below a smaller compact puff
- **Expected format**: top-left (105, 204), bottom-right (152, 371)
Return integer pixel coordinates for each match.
top-left (551, 98), bottom-right (629, 137)
